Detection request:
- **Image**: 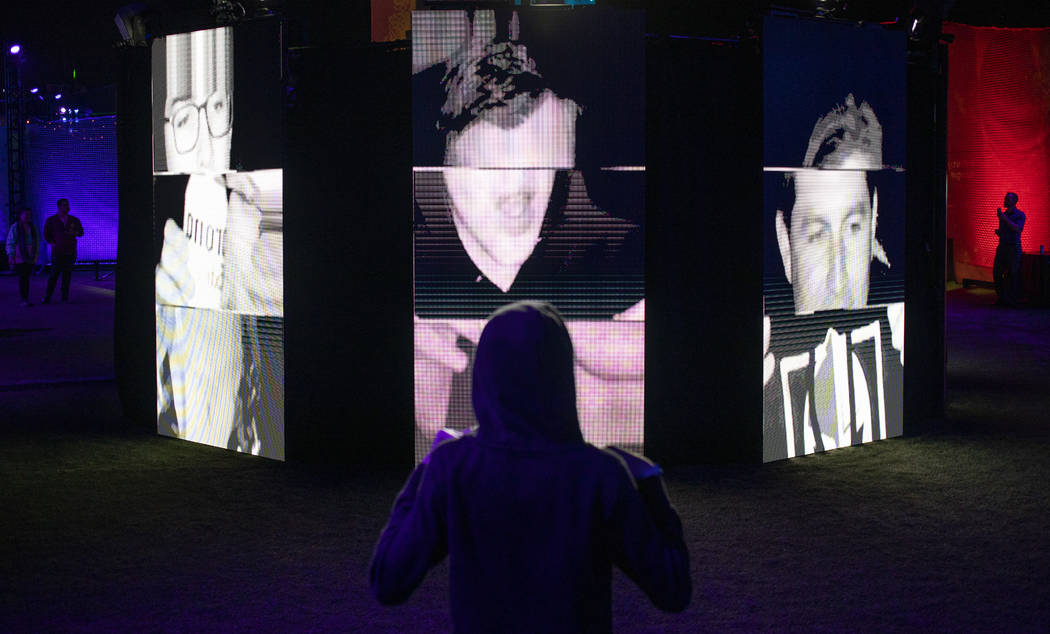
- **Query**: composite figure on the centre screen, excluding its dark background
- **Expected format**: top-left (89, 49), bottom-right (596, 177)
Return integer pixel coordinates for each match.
top-left (415, 12), bottom-right (645, 459)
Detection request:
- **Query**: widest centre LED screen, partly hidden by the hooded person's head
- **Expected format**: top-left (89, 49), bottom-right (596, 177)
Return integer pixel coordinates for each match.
top-left (412, 9), bottom-right (645, 461)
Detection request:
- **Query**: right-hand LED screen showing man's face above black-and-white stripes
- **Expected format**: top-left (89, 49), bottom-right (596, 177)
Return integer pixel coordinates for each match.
top-left (762, 18), bottom-right (906, 462)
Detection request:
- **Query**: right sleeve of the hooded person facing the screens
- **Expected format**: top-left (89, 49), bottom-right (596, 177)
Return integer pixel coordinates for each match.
top-left (612, 463), bottom-right (693, 612)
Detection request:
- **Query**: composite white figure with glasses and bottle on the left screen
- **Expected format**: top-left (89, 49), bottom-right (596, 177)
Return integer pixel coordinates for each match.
top-left (153, 28), bottom-right (284, 458)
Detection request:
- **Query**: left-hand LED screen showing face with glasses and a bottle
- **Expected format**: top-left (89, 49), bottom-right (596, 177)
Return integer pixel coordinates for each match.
top-left (151, 21), bottom-right (285, 460)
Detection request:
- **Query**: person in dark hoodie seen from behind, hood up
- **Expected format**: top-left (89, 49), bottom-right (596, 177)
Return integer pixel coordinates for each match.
top-left (371, 301), bottom-right (692, 632)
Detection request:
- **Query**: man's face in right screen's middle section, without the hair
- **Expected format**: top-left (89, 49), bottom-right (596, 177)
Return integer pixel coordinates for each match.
top-left (781, 170), bottom-right (874, 314)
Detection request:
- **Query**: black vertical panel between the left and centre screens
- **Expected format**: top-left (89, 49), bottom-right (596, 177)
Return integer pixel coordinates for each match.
top-left (285, 43), bottom-right (413, 466)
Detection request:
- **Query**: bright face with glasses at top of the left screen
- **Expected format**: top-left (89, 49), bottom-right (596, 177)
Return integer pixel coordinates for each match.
top-left (164, 28), bottom-right (233, 173)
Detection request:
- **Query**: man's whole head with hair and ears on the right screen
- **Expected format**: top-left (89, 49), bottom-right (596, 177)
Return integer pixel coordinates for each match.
top-left (775, 94), bottom-right (889, 315)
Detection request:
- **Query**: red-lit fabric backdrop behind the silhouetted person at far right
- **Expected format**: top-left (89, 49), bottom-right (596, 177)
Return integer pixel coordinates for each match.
top-left (944, 24), bottom-right (1050, 279)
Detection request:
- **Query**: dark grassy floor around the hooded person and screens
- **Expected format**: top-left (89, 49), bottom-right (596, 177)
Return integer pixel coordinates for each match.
top-left (0, 281), bottom-right (1050, 632)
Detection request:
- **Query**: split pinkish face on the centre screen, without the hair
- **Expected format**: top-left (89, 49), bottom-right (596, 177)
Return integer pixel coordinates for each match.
top-left (444, 92), bottom-right (576, 267)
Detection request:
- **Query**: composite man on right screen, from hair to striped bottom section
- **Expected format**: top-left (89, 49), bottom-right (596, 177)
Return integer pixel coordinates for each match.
top-left (763, 94), bottom-right (904, 461)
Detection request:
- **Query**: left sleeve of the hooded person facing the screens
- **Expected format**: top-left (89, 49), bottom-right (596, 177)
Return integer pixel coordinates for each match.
top-left (369, 455), bottom-right (448, 606)
